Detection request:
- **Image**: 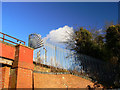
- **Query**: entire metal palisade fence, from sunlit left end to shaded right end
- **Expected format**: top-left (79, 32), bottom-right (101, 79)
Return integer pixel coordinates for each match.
top-left (30, 33), bottom-right (120, 87)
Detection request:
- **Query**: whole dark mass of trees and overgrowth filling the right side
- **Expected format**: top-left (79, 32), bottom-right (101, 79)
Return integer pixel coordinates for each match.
top-left (66, 25), bottom-right (120, 88)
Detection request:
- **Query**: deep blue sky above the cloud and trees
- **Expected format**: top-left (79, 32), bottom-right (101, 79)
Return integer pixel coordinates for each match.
top-left (2, 2), bottom-right (118, 45)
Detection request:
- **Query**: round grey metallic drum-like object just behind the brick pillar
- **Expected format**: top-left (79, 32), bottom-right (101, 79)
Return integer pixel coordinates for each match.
top-left (28, 34), bottom-right (43, 49)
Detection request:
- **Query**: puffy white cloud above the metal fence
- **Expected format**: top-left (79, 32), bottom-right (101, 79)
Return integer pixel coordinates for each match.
top-left (43, 25), bottom-right (73, 43)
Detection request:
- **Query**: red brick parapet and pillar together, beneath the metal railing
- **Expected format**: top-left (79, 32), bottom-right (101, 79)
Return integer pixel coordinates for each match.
top-left (0, 42), bottom-right (34, 88)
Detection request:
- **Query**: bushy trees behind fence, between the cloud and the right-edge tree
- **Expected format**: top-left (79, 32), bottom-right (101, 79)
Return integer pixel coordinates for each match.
top-left (66, 28), bottom-right (104, 59)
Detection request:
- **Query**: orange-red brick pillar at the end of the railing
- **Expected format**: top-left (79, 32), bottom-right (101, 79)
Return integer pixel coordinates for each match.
top-left (13, 45), bottom-right (34, 88)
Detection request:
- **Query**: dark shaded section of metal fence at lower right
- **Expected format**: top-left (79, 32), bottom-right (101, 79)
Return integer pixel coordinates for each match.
top-left (77, 54), bottom-right (120, 88)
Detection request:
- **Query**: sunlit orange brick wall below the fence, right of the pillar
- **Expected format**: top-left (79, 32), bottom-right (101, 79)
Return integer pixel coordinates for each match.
top-left (34, 73), bottom-right (94, 88)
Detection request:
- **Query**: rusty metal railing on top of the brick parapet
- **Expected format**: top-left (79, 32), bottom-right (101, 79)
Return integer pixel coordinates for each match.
top-left (0, 32), bottom-right (25, 45)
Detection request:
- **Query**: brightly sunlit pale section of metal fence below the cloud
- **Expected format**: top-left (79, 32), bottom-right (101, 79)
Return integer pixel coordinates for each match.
top-left (34, 42), bottom-right (74, 70)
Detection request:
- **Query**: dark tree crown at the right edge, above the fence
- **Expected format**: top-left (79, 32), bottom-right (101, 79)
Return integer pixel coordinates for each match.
top-left (106, 25), bottom-right (120, 60)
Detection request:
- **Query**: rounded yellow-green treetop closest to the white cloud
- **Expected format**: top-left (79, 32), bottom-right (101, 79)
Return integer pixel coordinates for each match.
top-left (74, 28), bottom-right (92, 54)
